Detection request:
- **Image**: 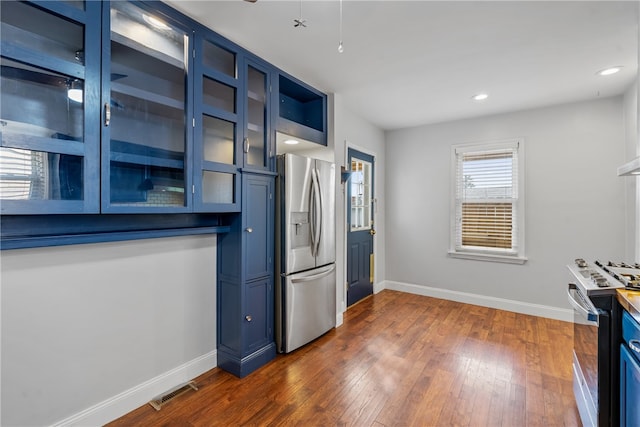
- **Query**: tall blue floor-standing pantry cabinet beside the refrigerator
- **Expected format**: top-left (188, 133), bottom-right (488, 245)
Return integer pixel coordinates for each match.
top-left (217, 172), bottom-right (276, 378)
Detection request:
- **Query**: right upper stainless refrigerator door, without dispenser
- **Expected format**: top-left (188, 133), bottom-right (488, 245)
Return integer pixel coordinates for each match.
top-left (315, 160), bottom-right (336, 266)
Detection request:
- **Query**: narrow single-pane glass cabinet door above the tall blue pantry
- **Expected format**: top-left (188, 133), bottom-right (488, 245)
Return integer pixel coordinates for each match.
top-left (243, 63), bottom-right (271, 169)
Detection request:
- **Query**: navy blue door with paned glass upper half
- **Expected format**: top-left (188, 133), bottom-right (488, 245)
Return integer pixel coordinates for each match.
top-left (347, 148), bottom-right (375, 306)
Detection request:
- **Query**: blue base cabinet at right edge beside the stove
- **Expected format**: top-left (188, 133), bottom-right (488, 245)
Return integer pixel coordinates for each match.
top-left (620, 311), bottom-right (640, 427)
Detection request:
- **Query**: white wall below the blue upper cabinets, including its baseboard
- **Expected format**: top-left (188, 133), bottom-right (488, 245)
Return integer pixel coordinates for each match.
top-left (0, 235), bottom-right (216, 426)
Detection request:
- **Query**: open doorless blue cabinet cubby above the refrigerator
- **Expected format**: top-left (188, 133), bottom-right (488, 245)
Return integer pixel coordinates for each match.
top-left (275, 73), bottom-right (327, 145)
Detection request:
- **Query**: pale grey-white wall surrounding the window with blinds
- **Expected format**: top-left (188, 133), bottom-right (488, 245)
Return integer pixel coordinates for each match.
top-left (385, 97), bottom-right (625, 312)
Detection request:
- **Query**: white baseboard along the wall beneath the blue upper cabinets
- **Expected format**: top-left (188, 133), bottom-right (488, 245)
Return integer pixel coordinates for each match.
top-left (53, 350), bottom-right (218, 427)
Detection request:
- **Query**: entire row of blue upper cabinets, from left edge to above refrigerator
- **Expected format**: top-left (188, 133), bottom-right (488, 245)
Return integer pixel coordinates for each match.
top-left (0, 0), bottom-right (320, 215)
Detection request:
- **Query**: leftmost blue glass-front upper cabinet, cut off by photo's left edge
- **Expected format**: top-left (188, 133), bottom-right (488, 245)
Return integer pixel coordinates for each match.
top-left (0, 1), bottom-right (100, 214)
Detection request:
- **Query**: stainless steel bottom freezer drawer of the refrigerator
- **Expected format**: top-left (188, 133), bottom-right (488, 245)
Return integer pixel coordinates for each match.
top-left (278, 264), bottom-right (336, 353)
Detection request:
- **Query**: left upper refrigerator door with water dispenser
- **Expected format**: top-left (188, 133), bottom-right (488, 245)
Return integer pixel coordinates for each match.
top-left (279, 154), bottom-right (316, 274)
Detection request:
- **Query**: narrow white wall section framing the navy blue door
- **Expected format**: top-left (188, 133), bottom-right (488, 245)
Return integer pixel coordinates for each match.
top-left (332, 94), bottom-right (387, 312)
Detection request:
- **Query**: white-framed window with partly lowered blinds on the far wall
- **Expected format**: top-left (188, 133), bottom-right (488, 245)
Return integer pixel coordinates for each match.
top-left (449, 140), bottom-right (526, 264)
